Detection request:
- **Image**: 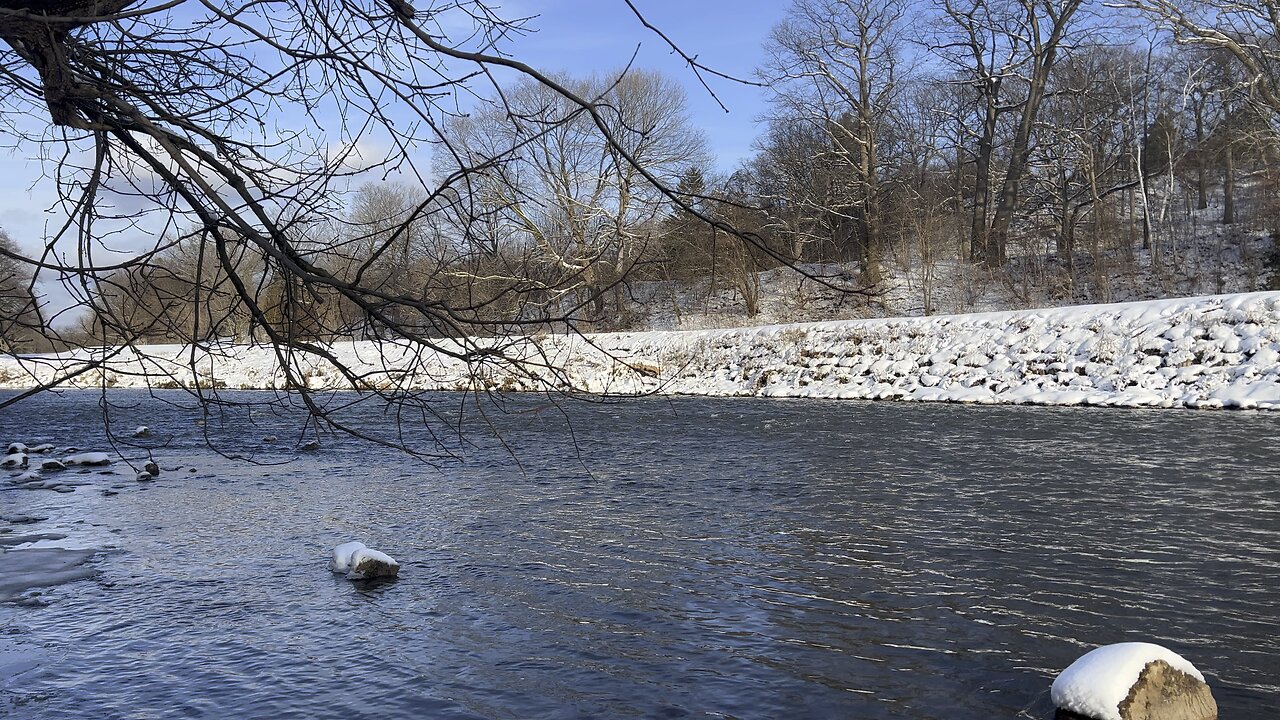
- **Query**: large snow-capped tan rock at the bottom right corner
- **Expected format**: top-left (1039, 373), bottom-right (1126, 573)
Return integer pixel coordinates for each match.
top-left (1050, 643), bottom-right (1217, 720)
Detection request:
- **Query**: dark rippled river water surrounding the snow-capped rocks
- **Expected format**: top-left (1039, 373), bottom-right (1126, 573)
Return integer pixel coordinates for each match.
top-left (0, 393), bottom-right (1280, 720)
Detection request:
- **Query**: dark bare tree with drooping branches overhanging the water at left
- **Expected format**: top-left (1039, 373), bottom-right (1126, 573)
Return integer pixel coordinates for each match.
top-left (0, 0), bottom-right (829, 453)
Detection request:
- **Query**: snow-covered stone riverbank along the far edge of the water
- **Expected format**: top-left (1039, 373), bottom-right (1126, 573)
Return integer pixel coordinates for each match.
top-left (0, 292), bottom-right (1280, 410)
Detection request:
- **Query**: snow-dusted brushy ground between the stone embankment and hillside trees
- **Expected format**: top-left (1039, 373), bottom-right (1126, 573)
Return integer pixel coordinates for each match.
top-left (624, 220), bottom-right (1280, 331)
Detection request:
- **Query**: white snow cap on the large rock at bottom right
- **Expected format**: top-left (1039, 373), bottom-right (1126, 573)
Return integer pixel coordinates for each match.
top-left (1050, 642), bottom-right (1204, 720)
